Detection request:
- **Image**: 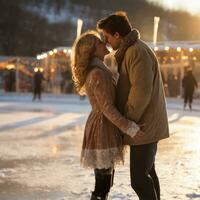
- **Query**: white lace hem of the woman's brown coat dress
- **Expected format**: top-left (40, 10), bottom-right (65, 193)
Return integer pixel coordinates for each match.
top-left (81, 147), bottom-right (124, 169)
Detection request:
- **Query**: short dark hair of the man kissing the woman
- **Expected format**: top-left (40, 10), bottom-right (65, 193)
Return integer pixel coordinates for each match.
top-left (97, 11), bottom-right (132, 37)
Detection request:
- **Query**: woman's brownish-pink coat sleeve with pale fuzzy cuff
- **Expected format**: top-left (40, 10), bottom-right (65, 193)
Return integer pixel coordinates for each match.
top-left (90, 69), bottom-right (140, 137)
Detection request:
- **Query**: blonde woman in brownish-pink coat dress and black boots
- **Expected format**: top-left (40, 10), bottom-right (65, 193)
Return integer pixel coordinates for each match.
top-left (72, 31), bottom-right (143, 200)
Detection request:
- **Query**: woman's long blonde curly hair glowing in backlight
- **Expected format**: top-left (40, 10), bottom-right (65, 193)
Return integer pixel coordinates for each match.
top-left (71, 31), bottom-right (100, 95)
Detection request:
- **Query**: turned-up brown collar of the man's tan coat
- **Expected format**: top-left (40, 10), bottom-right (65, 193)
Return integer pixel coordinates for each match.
top-left (115, 29), bottom-right (140, 68)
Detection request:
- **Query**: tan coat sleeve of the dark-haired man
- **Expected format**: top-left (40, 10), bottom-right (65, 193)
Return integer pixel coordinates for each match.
top-left (125, 49), bottom-right (154, 123)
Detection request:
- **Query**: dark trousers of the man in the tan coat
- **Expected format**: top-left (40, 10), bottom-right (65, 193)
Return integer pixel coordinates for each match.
top-left (130, 142), bottom-right (160, 200)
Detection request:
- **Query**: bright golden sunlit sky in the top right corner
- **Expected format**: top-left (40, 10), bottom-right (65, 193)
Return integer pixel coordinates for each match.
top-left (148, 0), bottom-right (200, 15)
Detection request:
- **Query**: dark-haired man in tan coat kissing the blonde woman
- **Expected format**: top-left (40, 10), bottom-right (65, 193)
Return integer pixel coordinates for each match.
top-left (97, 12), bottom-right (169, 200)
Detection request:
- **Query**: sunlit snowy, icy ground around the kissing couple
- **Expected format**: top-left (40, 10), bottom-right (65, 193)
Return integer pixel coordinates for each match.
top-left (0, 94), bottom-right (200, 200)
